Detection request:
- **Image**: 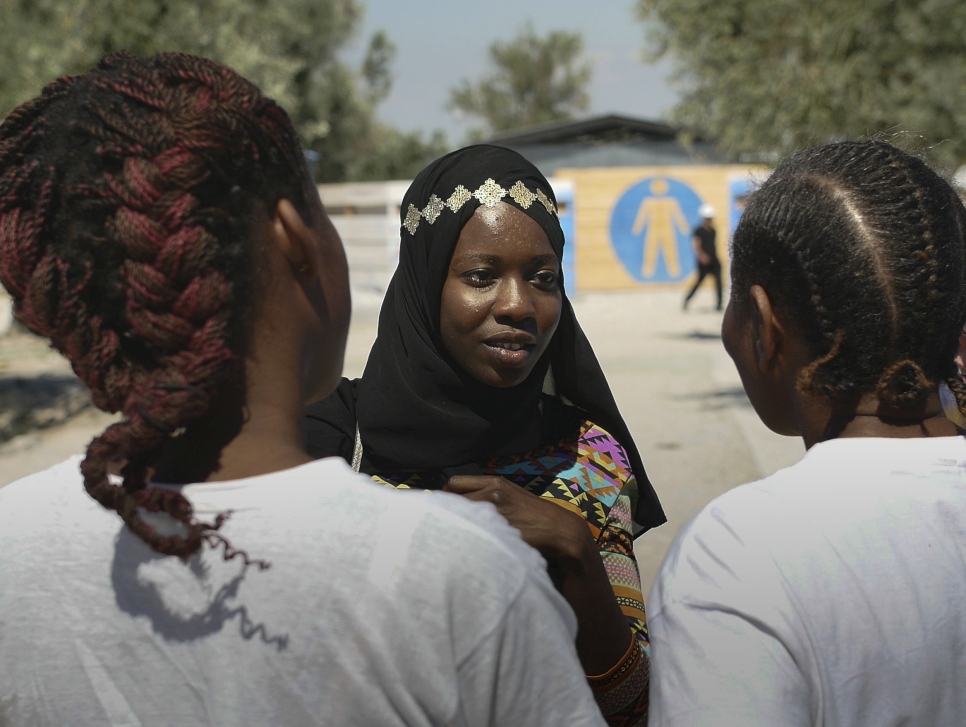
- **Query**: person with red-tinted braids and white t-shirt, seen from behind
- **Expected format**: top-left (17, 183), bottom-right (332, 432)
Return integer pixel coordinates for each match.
top-left (0, 54), bottom-right (604, 727)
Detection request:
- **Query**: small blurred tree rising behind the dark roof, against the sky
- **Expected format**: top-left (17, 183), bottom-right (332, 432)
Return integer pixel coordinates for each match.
top-left (447, 25), bottom-right (593, 135)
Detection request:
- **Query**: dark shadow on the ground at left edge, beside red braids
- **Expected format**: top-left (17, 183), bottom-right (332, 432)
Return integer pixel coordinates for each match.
top-left (0, 374), bottom-right (91, 442)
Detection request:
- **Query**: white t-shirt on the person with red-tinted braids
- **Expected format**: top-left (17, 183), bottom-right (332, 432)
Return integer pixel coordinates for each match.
top-left (0, 457), bottom-right (603, 727)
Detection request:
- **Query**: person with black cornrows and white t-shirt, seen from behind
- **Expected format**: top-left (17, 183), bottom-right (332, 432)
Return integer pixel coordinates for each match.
top-left (647, 142), bottom-right (966, 727)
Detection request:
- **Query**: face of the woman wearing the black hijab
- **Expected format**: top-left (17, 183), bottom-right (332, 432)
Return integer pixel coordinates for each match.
top-left (439, 202), bottom-right (562, 388)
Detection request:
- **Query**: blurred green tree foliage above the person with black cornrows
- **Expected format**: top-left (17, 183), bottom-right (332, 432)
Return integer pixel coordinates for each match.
top-left (637, 0), bottom-right (966, 165)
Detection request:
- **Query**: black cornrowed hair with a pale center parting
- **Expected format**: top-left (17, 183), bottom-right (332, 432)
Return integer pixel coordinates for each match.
top-left (731, 141), bottom-right (966, 413)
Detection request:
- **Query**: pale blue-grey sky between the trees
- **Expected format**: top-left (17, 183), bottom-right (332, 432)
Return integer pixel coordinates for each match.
top-left (346, 0), bottom-right (677, 142)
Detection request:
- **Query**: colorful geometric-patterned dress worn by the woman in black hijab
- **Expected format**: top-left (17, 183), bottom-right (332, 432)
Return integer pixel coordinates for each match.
top-left (373, 421), bottom-right (650, 726)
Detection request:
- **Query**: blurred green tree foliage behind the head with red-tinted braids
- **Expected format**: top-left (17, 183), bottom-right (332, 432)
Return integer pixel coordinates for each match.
top-left (0, 0), bottom-right (442, 181)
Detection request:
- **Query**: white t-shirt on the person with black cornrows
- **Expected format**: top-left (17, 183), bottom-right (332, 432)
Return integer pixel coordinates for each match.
top-left (647, 437), bottom-right (966, 727)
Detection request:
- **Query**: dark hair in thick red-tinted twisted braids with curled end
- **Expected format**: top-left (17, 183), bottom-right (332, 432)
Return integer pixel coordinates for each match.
top-left (0, 53), bottom-right (308, 561)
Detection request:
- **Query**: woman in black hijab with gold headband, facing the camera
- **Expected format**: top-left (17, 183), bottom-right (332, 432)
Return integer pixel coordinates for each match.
top-left (306, 146), bottom-right (665, 724)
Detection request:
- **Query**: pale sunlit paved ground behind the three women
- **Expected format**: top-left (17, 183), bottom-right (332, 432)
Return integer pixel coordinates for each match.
top-left (0, 290), bottom-right (803, 592)
